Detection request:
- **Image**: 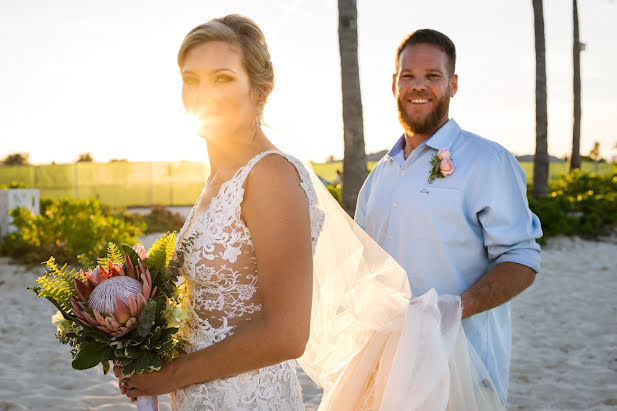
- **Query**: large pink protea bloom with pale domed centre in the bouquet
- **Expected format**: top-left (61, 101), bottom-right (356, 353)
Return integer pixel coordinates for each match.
top-left (71, 255), bottom-right (156, 337)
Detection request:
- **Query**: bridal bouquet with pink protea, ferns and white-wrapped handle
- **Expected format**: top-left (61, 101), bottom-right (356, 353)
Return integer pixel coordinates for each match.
top-left (31, 233), bottom-right (186, 410)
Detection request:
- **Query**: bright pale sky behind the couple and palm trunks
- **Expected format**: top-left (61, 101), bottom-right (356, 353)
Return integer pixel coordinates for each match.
top-left (0, 0), bottom-right (617, 164)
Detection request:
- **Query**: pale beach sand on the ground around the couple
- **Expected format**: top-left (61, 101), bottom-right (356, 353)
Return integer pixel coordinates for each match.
top-left (0, 236), bottom-right (617, 410)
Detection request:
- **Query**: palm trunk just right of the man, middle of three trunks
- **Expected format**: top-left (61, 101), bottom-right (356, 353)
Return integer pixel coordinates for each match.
top-left (532, 0), bottom-right (548, 198)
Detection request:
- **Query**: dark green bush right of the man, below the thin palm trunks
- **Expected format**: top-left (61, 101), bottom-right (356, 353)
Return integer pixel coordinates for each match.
top-left (529, 168), bottom-right (617, 243)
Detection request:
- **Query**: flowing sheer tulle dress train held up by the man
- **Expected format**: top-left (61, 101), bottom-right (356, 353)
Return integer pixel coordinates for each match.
top-left (298, 160), bottom-right (504, 411)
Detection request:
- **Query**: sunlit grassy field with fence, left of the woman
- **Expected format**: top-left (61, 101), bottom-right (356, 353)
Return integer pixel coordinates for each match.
top-left (0, 161), bottom-right (210, 207)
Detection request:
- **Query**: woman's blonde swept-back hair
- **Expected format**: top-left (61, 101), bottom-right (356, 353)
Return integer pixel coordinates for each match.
top-left (178, 14), bottom-right (274, 103)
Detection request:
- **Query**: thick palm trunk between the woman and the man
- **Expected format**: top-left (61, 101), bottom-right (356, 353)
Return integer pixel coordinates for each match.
top-left (338, 0), bottom-right (367, 216)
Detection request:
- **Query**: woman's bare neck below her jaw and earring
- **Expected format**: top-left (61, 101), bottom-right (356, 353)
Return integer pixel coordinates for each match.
top-left (206, 129), bottom-right (276, 175)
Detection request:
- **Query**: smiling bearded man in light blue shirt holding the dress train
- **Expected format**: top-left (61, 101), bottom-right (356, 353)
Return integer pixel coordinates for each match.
top-left (355, 29), bottom-right (542, 403)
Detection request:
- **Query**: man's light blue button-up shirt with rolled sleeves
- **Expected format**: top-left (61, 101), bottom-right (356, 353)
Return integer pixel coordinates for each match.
top-left (355, 119), bottom-right (542, 403)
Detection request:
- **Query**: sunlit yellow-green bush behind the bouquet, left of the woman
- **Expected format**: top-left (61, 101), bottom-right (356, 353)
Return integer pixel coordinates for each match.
top-left (0, 198), bottom-right (145, 264)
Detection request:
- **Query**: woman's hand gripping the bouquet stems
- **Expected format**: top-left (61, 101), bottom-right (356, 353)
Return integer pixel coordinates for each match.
top-left (114, 363), bottom-right (178, 401)
